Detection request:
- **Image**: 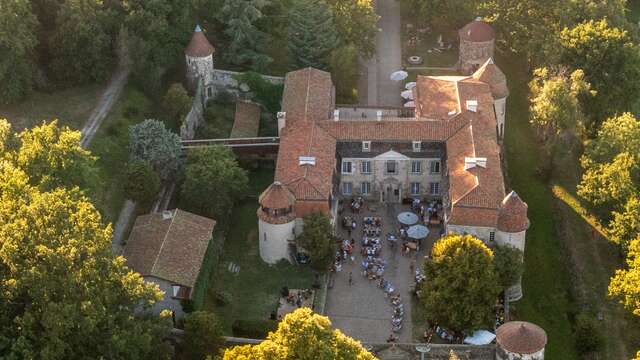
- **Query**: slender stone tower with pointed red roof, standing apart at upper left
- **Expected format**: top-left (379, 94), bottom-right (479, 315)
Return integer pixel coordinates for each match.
top-left (184, 25), bottom-right (215, 93)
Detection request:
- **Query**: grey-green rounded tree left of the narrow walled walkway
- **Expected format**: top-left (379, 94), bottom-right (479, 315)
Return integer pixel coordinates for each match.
top-left (129, 119), bottom-right (182, 180)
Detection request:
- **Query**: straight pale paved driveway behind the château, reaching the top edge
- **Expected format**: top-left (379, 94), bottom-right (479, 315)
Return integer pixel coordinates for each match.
top-left (360, 0), bottom-right (402, 106)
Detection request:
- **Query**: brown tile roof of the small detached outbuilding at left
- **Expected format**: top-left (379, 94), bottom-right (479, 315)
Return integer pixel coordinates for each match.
top-left (124, 209), bottom-right (216, 288)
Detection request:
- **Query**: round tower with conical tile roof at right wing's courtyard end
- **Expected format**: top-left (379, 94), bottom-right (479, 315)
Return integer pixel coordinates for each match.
top-left (496, 191), bottom-right (529, 301)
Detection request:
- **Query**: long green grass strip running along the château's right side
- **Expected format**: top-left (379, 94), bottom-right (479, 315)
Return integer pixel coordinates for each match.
top-left (499, 54), bottom-right (578, 360)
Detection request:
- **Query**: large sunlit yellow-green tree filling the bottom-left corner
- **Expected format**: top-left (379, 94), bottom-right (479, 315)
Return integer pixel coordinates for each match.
top-left (0, 165), bottom-right (169, 359)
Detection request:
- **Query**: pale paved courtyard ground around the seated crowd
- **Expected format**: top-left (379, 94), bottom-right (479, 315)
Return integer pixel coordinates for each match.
top-left (325, 203), bottom-right (437, 343)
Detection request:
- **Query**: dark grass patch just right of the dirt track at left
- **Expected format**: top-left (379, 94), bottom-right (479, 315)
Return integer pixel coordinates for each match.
top-left (89, 85), bottom-right (152, 223)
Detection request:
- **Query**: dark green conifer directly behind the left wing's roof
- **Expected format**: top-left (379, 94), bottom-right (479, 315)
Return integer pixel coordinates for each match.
top-left (288, 0), bottom-right (338, 70)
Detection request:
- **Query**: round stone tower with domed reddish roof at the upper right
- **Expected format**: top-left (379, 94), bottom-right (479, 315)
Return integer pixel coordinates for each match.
top-left (458, 18), bottom-right (496, 74)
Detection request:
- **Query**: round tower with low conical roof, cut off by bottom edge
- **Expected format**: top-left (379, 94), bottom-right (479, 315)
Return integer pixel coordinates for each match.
top-left (496, 321), bottom-right (547, 360)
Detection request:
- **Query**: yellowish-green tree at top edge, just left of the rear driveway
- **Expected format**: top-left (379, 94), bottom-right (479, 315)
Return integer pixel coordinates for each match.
top-left (327, 0), bottom-right (380, 58)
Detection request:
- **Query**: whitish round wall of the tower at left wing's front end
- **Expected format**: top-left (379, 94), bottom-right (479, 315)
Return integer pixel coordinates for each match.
top-left (258, 219), bottom-right (296, 264)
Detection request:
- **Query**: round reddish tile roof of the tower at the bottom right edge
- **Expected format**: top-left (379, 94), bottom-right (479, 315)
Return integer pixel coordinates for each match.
top-left (496, 321), bottom-right (547, 354)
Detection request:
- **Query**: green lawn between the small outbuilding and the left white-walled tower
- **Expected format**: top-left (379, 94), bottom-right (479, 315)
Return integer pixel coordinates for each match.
top-left (204, 169), bottom-right (313, 333)
